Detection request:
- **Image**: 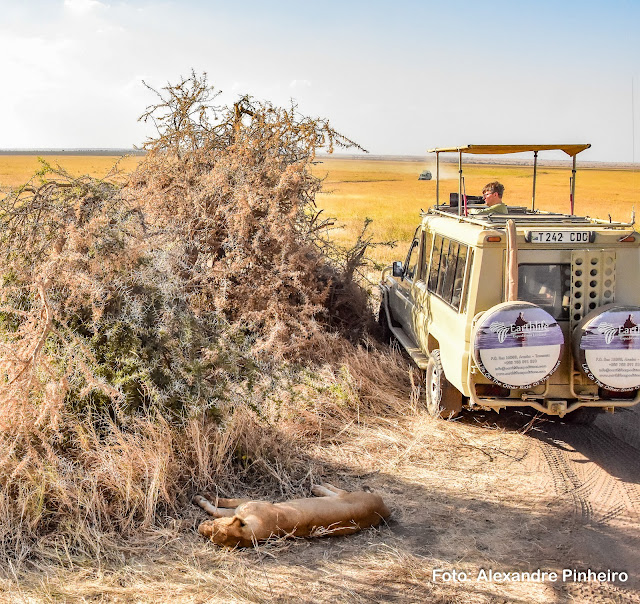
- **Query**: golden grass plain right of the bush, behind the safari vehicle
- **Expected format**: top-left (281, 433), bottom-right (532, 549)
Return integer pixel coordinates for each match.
top-left (314, 156), bottom-right (640, 262)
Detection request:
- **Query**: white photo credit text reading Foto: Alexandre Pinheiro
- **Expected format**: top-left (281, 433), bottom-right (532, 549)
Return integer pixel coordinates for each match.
top-left (431, 568), bottom-right (629, 583)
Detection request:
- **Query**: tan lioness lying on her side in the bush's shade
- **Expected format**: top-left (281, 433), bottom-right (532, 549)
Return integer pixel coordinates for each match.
top-left (193, 484), bottom-right (391, 547)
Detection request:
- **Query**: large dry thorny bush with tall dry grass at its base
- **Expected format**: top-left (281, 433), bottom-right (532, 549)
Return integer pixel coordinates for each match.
top-left (0, 75), bottom-right (407, 561)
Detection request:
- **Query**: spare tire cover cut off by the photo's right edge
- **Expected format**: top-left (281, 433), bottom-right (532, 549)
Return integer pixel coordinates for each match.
top-left (573, 304), bottom-right (640, 392)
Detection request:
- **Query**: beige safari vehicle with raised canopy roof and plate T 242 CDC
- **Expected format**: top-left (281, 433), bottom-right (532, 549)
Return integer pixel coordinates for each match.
top-left (379, 144), bottom-right (640, 423)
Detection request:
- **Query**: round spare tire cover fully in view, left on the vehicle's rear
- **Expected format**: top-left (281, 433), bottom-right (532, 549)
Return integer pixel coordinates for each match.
top-left (472, 301), bottom-right (564, 388)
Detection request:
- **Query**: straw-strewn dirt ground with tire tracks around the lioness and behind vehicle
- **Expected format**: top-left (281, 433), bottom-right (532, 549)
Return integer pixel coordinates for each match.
top-left (5, 398), bottom-right (640, 603)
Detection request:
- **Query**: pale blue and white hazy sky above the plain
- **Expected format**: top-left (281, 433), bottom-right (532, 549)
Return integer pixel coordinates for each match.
top-left (0, 0), bottom-right (640, 161)
